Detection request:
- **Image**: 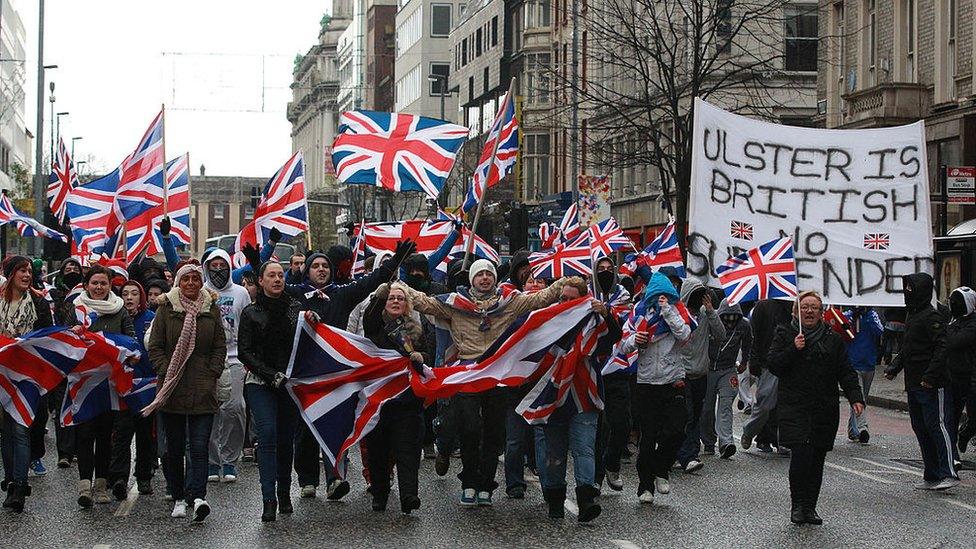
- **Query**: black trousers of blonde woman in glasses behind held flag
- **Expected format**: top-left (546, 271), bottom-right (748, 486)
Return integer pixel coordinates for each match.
top-left (365, 401), bottom-right (423, 501)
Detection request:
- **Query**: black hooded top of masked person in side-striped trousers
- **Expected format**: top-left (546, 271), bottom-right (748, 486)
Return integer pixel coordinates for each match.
top-left (885, 273), bottom-right (948, 391)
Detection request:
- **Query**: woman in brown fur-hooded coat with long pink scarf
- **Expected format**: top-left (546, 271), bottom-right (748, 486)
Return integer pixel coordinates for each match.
top-left (142, 263), bottom-right (227, 522)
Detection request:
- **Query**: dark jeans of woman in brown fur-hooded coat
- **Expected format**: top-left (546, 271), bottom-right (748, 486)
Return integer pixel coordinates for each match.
top-left (159, 412), bottom-right (214, 504)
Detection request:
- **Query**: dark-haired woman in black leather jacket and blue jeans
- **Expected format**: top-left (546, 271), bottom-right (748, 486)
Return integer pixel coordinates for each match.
top-left (237, 261), bottom-right (301, 522)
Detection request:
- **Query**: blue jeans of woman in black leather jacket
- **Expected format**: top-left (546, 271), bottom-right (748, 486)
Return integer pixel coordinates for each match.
top-left (244, 383), bottom-right (300, 501)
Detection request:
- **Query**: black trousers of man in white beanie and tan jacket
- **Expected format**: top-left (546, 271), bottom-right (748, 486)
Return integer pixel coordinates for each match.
top-left (451, 389), bottom-right (508, 492)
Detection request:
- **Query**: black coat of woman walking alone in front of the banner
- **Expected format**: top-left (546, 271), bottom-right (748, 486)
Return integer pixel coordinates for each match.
top-left (766, 323), bottom-right (864, 450)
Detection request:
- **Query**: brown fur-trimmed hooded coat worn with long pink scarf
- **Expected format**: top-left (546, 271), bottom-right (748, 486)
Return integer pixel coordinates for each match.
top-left (146, 288), bottom-right (227, 415)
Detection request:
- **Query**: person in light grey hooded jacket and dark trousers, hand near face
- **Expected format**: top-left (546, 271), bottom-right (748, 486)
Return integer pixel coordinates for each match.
top-left (678, 278), bottom-right (725, 473)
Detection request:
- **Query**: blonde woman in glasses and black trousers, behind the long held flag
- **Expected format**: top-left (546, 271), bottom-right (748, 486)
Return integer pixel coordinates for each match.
top-left (363, 282), bottom-right (436, 515)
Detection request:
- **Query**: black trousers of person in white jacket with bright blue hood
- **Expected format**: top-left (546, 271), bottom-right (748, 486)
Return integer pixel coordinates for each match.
top-left (633, 383), bottom-right (688, 495)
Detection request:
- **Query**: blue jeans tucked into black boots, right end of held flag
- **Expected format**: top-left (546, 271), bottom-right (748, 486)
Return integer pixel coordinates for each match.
top-left (540, 412), bottom-right (599, 489)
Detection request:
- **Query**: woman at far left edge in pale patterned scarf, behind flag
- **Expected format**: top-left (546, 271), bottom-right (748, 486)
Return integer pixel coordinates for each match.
top-left (0, 256), bottom-right (54, 513)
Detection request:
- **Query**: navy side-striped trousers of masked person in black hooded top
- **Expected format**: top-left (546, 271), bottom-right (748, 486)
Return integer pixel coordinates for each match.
top-left (908, 388), bottom-right (959, 482)
